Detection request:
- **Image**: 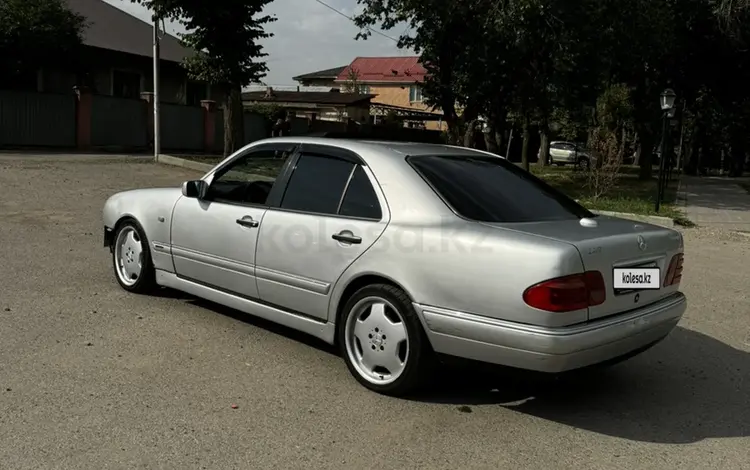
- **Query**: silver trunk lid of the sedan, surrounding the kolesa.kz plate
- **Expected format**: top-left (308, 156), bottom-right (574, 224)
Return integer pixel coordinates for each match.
top-left (482, 216), bottom-right (683, 320)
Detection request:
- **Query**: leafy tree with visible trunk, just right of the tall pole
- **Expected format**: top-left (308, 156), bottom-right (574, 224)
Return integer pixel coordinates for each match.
top-left (132, 0), bottom-right (276, 155)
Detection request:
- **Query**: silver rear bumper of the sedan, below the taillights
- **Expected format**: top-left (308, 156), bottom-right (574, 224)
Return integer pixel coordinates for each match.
top-left (415, 292), bottom-right (687, 372)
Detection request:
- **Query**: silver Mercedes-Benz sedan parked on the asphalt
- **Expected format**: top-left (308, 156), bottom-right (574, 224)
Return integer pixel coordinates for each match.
top-left (104, 137), bottom-right (686, 395)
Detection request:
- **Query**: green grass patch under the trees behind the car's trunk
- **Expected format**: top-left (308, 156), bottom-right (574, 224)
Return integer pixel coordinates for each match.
top-left (531, 166), bottom-right (689, 220)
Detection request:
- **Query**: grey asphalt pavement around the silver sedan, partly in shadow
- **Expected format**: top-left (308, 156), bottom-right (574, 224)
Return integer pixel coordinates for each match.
top-left (0, 156), bottom-right (750, 469)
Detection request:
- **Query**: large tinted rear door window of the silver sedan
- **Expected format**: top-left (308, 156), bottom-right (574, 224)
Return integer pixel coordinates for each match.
top-left (281, 154), bottom-right (354, 214)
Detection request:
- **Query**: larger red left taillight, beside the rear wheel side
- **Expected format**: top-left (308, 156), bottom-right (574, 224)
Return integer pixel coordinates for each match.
top-left (523, 271), bottom-right (607, 312)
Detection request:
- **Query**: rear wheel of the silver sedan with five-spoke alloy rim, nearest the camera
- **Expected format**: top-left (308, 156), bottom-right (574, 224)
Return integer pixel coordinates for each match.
top-left (338, 284), bottom-right (435, 397)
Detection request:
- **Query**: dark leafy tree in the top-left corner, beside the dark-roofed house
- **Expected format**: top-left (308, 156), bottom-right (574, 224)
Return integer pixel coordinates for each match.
top-left (0, 0), bottom-right (86, 90)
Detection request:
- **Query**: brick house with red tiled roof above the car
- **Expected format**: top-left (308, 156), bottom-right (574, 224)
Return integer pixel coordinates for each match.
top-left (294, 56), bottom-right (446, 129)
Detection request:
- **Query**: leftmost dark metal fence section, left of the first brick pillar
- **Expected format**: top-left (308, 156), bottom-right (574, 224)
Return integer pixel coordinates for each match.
top-left (0, 91), bottom-right (76, 147)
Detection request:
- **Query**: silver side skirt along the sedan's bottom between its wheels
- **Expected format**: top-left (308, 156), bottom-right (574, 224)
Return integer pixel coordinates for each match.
top-left (156, 269), bottom-right (336, 344)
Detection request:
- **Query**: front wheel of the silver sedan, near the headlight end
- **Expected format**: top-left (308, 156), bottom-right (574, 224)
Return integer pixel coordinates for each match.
top-left (112, 219), bottom-right (156, 294)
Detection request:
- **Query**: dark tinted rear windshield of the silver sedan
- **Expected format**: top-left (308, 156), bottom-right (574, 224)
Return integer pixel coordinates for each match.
top-left (407, 155), bottom-right (594, 223)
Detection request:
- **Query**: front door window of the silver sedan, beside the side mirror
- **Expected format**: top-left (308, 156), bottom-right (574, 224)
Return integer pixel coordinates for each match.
top-left (206, 144), bottom-right (295, 205)
